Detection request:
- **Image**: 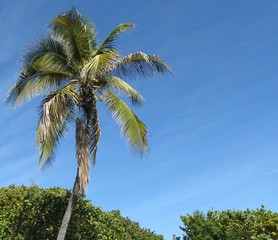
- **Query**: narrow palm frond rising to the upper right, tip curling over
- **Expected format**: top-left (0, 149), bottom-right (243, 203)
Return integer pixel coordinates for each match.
top-left (97, 23), bottom-right (135, 54)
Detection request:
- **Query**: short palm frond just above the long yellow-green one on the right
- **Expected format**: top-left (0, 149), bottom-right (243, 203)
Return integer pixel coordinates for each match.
top-left (105, 76), bottom-right (144, 104)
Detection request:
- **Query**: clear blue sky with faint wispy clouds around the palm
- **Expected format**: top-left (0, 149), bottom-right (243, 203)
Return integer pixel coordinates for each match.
top-left (0, 0), bottom-right (278, 240)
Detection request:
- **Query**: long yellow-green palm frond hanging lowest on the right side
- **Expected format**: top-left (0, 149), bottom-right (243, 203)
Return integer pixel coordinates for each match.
top-left (104, 90), bottom-right (149, 155)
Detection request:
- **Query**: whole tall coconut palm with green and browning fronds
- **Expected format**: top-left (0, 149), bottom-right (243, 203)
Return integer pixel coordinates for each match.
top-left (7, 8), bottom-right (171, 240)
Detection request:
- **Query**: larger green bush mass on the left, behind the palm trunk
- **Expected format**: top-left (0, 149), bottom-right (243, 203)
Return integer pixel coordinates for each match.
top-left (0, 186), bottom-right (163, 240)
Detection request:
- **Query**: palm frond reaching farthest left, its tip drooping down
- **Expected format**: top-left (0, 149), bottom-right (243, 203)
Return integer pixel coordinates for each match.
top-left (6, 64), bottom-right (72, 106)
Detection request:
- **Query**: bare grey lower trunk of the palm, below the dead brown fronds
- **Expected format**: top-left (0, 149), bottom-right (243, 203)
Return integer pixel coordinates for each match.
top-left (57, 170), bottom-right (79, 240)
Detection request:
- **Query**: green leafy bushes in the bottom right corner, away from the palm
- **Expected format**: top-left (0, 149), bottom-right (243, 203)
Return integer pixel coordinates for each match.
top-left (175, 206), bottom-right (278, 240)
